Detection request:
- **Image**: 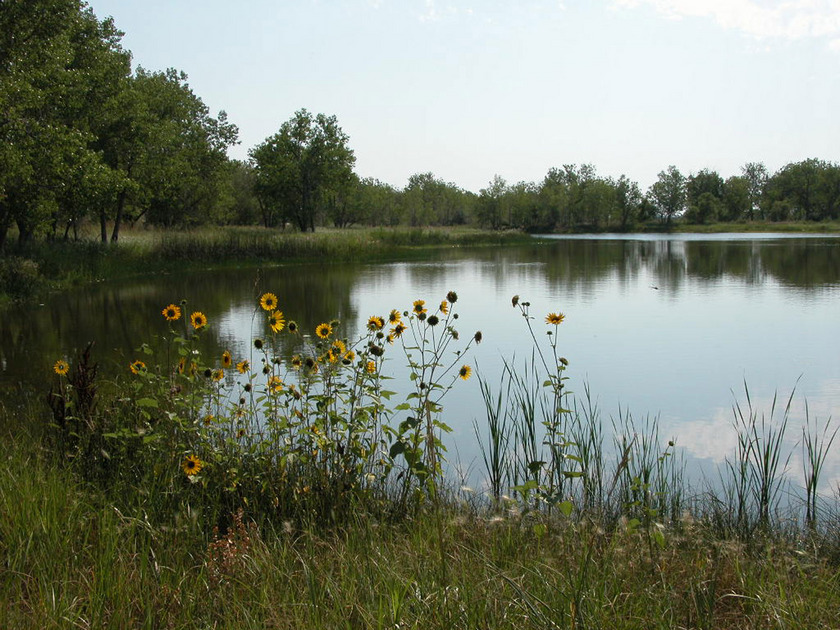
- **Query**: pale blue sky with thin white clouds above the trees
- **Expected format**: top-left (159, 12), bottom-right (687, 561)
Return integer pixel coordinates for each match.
top-left (88, 0), bottom-right (840, 192)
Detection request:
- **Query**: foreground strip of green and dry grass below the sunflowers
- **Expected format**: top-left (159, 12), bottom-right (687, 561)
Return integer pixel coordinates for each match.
top-left (0, 428), bottom-right (840, 629)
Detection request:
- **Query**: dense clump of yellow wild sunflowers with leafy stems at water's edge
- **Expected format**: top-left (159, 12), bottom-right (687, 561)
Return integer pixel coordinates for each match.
top-left (48, 292), bottom-right (472, 526)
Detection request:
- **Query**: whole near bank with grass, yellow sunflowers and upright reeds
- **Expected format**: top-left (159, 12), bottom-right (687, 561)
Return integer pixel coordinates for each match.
top-left (0, 292), bottom-right (840, 629)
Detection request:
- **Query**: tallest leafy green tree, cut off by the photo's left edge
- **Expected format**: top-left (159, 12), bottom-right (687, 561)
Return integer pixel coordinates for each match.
top-left (0, 0), bottom-right (130, 244)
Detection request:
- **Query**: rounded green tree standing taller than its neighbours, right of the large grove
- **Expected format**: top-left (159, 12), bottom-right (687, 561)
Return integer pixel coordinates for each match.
top-left (250, 109), bottom-right (356, 232)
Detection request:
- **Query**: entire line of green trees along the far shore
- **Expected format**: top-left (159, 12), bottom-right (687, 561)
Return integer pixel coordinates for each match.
top-left (0, 0), bottom-right (840, 247)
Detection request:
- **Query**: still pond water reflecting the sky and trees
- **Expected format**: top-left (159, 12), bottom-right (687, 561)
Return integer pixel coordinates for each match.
top-left (0, 234), bottom-right (840, 487)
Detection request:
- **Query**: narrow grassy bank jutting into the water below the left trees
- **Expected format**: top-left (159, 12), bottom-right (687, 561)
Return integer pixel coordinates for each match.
top-left (0, 227), bottom-right (529, 301)
